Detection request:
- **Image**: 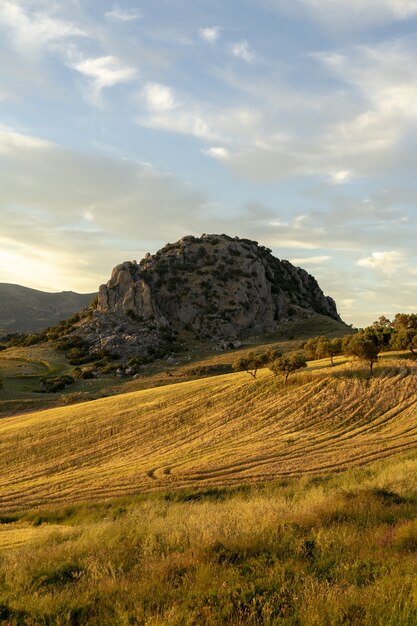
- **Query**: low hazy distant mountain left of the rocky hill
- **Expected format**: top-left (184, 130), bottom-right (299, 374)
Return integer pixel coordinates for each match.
top-left (0, 283), bottom-right (96, 333)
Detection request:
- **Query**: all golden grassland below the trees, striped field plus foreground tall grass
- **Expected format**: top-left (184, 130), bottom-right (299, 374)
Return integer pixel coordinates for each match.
top-left (0, 355), bottom-right (417, 626)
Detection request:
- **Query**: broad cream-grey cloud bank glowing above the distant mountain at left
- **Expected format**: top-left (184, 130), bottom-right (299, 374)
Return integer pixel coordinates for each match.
top-left (0, 128), bottom-right (207, 291)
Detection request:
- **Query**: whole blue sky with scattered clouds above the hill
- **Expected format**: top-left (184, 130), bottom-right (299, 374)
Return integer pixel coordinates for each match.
top-left (0, 0), bottom-right (417, 326)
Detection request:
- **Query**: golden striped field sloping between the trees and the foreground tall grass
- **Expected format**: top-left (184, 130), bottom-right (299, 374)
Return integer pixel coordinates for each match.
top-left (0, 358), bottom-right (417, 511)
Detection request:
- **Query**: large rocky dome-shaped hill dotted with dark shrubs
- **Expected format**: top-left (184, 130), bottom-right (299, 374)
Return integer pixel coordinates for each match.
top-left (76, 234), bottom-right (341, 356)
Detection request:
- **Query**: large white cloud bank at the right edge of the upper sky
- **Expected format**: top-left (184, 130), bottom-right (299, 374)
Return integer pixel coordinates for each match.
top-left (208, 42), bottom-right (417, 185)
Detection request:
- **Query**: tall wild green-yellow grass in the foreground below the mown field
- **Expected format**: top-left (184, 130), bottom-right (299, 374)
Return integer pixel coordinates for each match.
top-left (0, 454), bottom-right (417, 626)
